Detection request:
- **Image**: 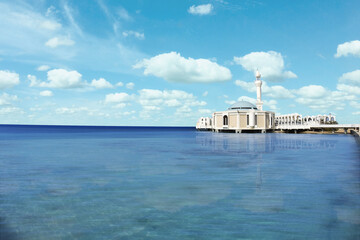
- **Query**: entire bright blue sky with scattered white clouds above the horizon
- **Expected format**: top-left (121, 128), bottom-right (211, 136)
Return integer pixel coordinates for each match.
top-left (0, 0), bottom-right (360, 126)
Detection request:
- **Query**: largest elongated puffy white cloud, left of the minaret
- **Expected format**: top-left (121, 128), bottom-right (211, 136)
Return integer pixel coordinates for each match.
top-left (133, 52), bottom-right (231, 83)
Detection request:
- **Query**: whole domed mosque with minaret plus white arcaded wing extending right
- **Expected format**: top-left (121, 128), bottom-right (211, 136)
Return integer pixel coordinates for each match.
top-left (196, 71), bottom-right (337, 133)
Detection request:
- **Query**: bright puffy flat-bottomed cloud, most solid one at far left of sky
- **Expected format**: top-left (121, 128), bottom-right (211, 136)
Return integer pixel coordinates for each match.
top-left (39, 69), bottom-right (85, 88)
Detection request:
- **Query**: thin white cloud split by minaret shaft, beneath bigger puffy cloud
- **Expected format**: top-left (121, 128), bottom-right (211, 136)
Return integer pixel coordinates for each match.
top-left (235, 80), bottom-right (295, 99)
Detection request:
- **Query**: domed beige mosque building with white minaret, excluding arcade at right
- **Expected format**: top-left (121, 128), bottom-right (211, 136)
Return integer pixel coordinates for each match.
top-left (196, 71), bottom-right (275, 133)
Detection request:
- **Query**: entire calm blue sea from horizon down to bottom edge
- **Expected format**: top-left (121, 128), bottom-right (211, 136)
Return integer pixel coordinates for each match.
top-left (0, 125), bottom-right (360, 240)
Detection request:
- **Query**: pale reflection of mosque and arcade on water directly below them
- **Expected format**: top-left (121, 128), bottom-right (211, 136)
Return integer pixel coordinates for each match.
top-left (196, 132), bottom-right (337, 153)
